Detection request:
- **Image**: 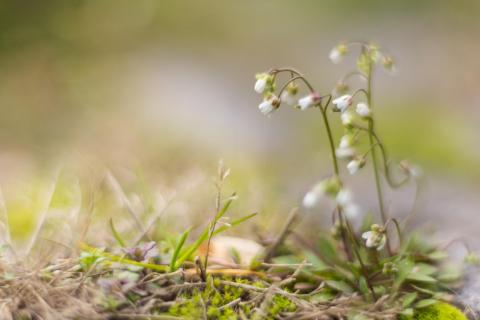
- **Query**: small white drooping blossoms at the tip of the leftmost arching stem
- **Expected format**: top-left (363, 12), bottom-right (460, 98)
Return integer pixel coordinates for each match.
top-left (254, 73), bottom-right (322, 116)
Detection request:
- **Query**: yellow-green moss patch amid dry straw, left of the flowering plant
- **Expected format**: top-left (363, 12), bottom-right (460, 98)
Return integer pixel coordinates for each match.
top-left (168, 278), bottom-right (296, 320)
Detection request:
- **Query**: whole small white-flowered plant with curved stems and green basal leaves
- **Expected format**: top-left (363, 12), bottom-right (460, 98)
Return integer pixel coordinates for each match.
top-left (254, 42), bottom-right (468, 315)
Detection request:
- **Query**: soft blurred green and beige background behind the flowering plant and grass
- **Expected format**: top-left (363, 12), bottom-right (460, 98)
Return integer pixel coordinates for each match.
top-left (0, 0), bottom-right (480, 252)
